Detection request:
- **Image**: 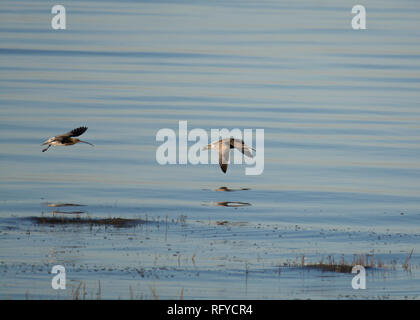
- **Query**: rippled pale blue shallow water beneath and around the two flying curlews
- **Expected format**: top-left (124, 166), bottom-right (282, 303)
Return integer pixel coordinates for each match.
top-left (0, 0), bottom-right (420, 299)
